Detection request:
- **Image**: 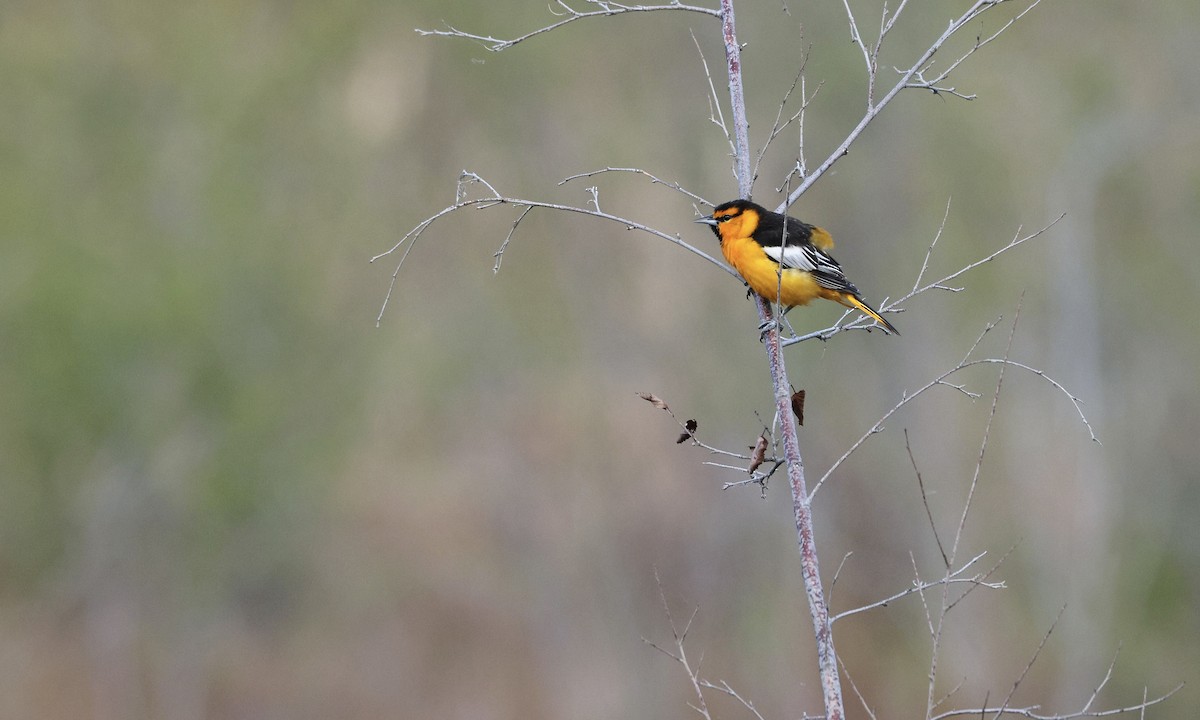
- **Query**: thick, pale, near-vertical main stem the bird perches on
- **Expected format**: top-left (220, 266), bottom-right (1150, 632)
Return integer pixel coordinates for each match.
top-left (721, 0), bottom-right (846, 720)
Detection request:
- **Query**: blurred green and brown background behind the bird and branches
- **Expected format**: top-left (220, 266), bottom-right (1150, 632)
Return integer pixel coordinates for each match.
top-left (0, 0), bottom-right (1200, 720)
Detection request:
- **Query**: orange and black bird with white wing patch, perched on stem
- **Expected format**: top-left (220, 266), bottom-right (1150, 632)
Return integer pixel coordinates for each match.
top-left (696, 200), bottom-right (900, 335)
